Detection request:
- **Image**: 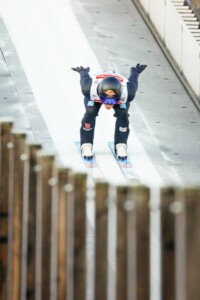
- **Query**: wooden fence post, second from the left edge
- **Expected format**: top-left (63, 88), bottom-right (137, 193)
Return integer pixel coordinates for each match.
top-left (10, 133), bottom-right (28, 300)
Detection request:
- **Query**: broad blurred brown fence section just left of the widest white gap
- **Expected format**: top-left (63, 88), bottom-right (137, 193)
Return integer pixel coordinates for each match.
top-left (116, 187), bottom-right (150, 300)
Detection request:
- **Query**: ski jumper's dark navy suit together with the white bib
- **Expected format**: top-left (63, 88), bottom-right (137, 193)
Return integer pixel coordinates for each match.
top-left (80, 69), bottom-right (139, 145)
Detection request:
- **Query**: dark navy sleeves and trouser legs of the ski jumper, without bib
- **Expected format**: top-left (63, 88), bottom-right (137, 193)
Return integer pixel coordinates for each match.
top-left (80, 69), bottom-right (139, 145)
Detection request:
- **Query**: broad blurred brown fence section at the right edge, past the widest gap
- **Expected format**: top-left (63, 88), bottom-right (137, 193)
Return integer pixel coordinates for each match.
top-left (161, 188), bottom-right (200, 300)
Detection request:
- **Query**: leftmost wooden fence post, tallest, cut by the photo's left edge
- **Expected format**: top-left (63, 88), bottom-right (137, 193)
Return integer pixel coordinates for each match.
top-left (0, 121), bottom-right (13, 300)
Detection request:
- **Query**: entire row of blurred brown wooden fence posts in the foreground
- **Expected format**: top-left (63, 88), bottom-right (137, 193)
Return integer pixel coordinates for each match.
top-left (0, 121), bottom-right (200, 300)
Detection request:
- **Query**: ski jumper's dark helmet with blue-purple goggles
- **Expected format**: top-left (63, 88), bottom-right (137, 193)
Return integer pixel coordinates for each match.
top-left (97, 76), bottom-right (122, 105)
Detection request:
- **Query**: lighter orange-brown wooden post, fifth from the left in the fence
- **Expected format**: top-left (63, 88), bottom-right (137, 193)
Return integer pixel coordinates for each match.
top-left (57, 168), bottom-right (73, 300)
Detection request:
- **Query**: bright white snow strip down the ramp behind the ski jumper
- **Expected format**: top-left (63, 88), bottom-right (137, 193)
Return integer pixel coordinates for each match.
top-left (0, 0), bottom-right (166, 186)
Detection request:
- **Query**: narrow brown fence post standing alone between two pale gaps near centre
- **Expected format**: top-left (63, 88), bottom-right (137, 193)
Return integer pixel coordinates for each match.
top-left (95, 182), bottom-right (109, 300)
